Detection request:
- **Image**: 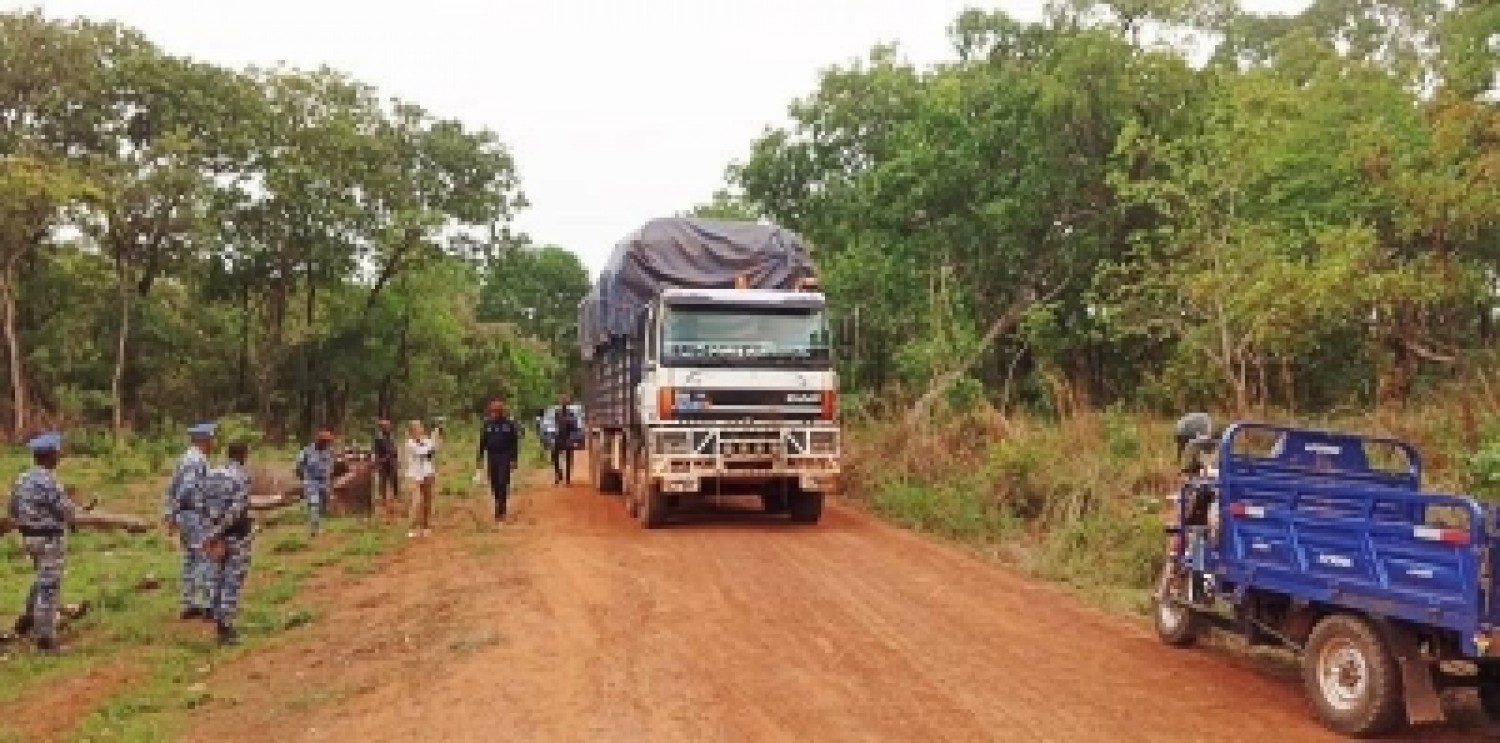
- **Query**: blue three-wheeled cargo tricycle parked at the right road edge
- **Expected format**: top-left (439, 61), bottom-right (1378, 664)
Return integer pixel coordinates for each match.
top-left (1157, 422), bottom-right (1500, 735)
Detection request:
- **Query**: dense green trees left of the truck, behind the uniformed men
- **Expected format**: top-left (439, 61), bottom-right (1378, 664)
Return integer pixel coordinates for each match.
top-left (0, 12), bottom-right (588, 435)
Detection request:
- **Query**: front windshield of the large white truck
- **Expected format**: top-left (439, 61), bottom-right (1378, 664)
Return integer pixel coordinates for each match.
top-left (662, 305), bottom-right (828, 368)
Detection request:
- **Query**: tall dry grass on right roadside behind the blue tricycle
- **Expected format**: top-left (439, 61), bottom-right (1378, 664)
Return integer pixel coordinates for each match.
top-left (845, 387), bottom-right (1500, 615)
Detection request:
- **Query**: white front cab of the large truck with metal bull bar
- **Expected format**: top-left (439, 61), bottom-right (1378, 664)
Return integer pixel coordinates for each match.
top-left (636, 290), bottom-right (839, 501)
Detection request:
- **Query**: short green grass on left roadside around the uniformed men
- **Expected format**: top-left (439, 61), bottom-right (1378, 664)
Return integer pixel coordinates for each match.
top-left (0, 426), bottom-right (510, 741)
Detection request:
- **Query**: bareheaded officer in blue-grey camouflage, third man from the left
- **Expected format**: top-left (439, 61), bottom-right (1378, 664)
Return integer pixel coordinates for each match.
top-left (201, 441), bottom-right (252, 645)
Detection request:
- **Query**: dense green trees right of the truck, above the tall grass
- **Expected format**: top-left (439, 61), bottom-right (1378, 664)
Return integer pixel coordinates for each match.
top-left (698, 0), bottom-right (1500, 414)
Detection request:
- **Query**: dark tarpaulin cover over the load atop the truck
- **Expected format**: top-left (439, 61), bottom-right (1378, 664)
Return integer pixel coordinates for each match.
top-left (578, 218), bottom-right (816, 359)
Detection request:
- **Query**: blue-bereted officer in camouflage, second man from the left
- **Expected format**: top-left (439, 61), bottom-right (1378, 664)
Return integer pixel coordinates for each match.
top-left (162, 423), bottom-right (218, 620)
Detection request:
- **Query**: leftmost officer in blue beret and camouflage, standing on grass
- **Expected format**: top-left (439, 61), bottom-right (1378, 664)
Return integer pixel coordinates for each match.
top-left (8, 434), bottom-right (78, 653)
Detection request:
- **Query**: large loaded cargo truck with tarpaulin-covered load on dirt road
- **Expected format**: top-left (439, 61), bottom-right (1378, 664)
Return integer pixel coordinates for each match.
top-left (579, 218), bottom-right (842, 528)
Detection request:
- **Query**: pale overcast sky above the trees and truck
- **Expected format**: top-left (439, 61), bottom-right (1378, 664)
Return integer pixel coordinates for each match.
top-left (17, 0), bottom-right (1307, 272)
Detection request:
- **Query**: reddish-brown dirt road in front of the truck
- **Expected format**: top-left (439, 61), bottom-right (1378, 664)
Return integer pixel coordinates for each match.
top-left (191, 474), bottom-right (1475, 743)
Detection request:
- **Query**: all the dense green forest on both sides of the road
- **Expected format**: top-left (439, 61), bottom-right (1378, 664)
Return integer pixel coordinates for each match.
top-left (0, 0), bottom-right (1500, 447)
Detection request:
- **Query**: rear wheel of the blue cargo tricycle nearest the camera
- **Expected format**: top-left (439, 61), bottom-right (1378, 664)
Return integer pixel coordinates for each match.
top-left (1302, 614), bottom-right (1404, 737)
